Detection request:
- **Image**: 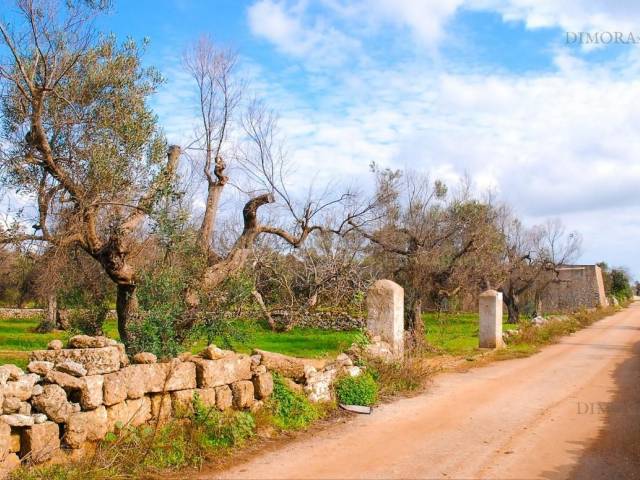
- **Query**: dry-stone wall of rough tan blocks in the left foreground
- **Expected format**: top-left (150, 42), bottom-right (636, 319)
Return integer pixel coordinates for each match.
top-left (0, 335), bottom-right (273, 479)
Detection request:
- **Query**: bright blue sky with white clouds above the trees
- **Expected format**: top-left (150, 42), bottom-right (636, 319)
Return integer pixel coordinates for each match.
top-left (5, 0), bottom-right (640, 277)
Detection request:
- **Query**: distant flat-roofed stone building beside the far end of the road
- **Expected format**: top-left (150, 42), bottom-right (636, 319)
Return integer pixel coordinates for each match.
top-left (540, 265), bottom-right (608, 313)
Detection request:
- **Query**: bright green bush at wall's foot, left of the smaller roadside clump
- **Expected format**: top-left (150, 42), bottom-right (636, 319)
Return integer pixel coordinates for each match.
top-left (269, 375), bottom-right (322, 430)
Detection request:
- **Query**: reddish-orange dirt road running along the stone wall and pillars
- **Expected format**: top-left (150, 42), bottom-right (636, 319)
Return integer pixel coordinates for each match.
top-left (209, 303), bottom-right (640, 479)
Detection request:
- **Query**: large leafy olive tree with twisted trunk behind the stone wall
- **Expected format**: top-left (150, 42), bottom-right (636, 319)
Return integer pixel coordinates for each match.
top-left (0, 0), bottom-right (174, 343)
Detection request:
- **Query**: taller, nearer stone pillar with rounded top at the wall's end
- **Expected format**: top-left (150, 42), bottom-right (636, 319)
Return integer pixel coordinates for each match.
top-left (367, 280), bottom-right (404, 357)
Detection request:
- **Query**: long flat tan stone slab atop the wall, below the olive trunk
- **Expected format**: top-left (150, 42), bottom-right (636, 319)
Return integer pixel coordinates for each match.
top-left (29, 346), bottom-right (121, 375)
